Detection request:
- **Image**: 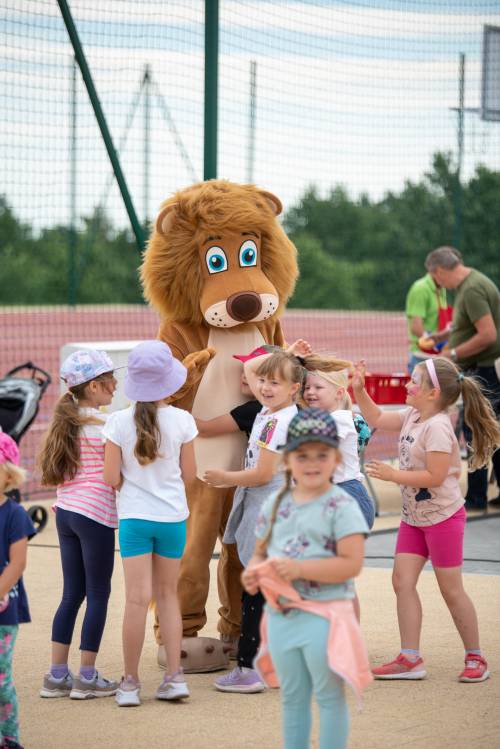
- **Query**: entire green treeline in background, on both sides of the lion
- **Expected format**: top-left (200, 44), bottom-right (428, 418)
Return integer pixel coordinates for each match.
top-left (0, 153), bottom-right (500, 310)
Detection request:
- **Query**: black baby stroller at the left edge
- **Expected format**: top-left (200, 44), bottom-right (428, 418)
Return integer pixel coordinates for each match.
top-left (0, 362), bottom-right (52, 532)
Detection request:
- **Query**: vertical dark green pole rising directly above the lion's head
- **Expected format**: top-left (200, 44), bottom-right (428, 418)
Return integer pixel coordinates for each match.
top-left (203, 0), bottom-right (219, 179)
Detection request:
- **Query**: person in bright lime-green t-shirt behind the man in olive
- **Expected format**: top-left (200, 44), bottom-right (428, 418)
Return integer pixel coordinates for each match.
top-left (405, 273), bottom-right (447, 374)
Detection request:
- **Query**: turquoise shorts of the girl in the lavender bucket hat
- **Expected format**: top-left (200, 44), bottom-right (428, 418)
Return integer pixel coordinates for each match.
top-left (118, 518), bottom-right (186, 559)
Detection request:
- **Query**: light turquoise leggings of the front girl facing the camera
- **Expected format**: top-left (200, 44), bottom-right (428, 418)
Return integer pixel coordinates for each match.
top-left (267, 610), bottom-right (349, 749)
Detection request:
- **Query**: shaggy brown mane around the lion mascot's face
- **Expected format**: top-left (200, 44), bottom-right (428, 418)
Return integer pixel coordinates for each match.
top-left (141, 180), bottom-right (298, 325)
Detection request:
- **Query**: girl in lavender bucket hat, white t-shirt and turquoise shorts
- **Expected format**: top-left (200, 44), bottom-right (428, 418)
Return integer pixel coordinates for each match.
top-left (103, 341), bottom-right (198, 707)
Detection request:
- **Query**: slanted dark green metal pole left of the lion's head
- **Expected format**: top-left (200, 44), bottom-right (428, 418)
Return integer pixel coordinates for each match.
top-left (57, 0), bottom-right (145, 251)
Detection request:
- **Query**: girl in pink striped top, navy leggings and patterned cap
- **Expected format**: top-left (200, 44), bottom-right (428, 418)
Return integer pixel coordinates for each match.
top-left (39, 349), bottom-right (118, 699)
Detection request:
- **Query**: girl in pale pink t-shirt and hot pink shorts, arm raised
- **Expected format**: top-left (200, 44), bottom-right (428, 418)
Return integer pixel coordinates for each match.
top-left (353, 357), bottom-right (500, 682)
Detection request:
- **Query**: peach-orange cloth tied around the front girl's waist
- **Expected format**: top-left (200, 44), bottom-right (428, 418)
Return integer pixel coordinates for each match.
top-left (254, 560), bottom-right (373, 706)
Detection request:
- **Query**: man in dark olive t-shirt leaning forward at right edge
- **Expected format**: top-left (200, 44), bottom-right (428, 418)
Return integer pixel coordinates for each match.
top-left (425, 247), bottom-right (500, 510)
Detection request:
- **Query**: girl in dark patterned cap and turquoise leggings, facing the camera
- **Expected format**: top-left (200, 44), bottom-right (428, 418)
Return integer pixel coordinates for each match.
top-left (242, 408), bottom-right (371, 749)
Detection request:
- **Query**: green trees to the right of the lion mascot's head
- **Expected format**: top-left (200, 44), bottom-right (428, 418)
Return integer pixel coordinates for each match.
top-left (285, 153), bottom-right (500, 310)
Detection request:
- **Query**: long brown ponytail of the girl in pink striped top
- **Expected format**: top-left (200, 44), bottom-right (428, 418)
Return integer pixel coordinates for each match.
top-left (38, 383), bottom-right (87, 486)
